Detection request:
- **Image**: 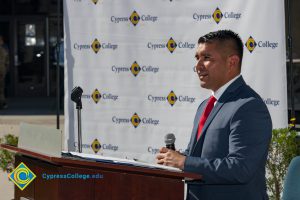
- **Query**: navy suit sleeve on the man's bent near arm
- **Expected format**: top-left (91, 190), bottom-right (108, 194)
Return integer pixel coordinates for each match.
top-left (184, 99), bottom-right (272, 184)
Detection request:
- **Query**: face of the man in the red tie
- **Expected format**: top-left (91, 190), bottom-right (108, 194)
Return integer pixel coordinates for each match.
top-left (195, 42), bottom-right (230, 91)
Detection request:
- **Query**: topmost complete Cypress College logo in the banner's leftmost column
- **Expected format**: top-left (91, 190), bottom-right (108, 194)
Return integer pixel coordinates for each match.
top-left (73, 38), bottom-right (118, 54)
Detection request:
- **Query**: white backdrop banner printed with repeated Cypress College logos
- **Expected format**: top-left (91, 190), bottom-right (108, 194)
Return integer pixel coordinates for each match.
top-left (64, 0), bottom-right (287, 161)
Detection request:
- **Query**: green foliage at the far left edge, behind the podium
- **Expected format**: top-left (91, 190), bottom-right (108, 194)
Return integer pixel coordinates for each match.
top-left (0, 134), bottom-right (18, 173)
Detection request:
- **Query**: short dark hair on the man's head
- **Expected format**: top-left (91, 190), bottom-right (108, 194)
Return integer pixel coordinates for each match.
top-left (198, 30), bottom-right (243, 63)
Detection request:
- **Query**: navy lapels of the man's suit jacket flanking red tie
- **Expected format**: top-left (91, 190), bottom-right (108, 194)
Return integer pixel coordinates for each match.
top-left (191, 76), bottom-right (246, 153)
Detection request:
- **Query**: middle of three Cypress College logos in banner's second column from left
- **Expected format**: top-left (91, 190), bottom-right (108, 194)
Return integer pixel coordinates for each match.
top-left (111, 61), bottom-right (159, 77)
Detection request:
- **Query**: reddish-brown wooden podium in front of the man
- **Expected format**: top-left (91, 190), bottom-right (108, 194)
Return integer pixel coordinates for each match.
top-left (1, 145), bottom-right (201, 200)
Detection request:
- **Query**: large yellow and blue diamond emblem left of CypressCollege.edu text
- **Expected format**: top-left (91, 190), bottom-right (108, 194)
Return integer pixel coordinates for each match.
top-left (8, 162), bottom-right (36, 190)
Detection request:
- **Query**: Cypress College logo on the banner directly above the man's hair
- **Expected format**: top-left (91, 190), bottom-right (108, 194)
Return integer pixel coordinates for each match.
top-left (193, 7), bottom-right (242, 24)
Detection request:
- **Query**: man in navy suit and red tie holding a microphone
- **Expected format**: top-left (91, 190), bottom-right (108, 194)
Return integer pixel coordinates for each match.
top-left (157, 30), bottom-right (272, 200)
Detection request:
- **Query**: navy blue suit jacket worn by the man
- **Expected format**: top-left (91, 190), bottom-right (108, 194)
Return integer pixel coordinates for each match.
top-left (184, 77), bottom-right (272, 200)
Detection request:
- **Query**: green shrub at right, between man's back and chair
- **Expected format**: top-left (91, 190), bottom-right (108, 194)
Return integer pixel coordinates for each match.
top-left (266, 128), bottom-right (298, 200)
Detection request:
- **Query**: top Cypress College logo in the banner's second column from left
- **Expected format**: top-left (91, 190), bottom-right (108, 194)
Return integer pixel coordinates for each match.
top-left (110, 10), bottom-right (158, 26)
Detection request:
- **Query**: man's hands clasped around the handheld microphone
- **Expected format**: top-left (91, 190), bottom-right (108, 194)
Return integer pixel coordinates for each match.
top-left (156, 147), bottom-right (185, 170)
